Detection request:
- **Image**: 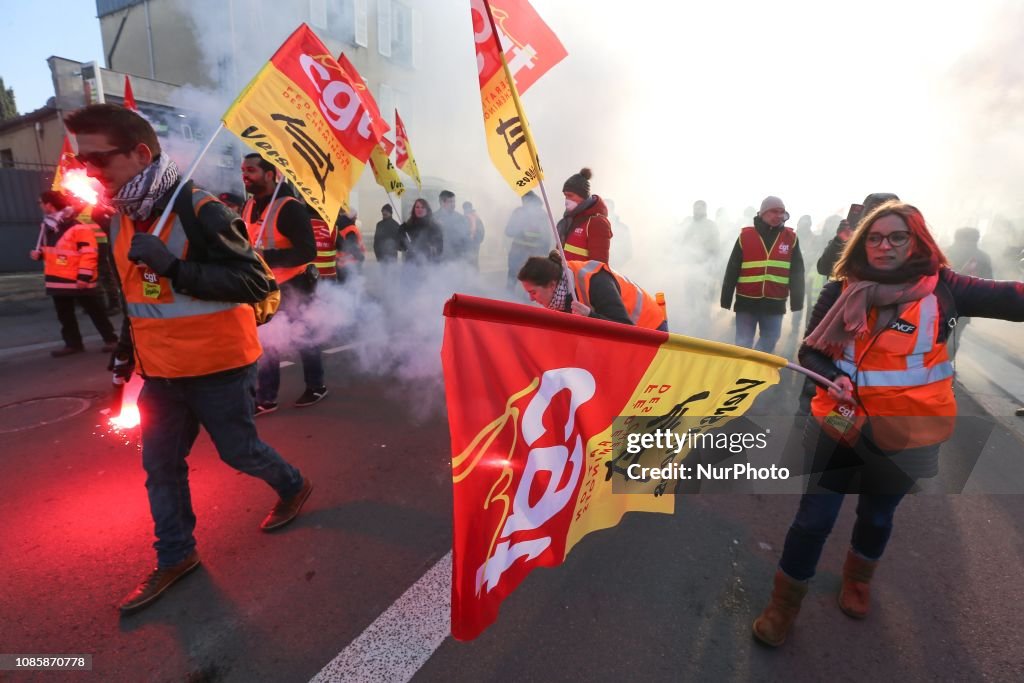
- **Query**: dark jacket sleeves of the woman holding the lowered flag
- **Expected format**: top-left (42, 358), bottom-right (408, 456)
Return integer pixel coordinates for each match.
top-left (800, 268), bottom-right (1024, 380)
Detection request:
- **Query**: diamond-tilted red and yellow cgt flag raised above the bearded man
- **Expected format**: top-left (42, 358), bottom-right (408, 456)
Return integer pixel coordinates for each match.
top-left (223, 24), bottom-right (387, 224)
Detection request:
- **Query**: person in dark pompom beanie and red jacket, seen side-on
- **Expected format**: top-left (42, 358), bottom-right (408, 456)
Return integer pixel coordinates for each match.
top-left (558, 168), bottom-right (611, 263)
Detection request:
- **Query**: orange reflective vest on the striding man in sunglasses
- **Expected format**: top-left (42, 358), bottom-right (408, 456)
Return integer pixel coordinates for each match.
top-left (111, 189), bottom-right (262, 379)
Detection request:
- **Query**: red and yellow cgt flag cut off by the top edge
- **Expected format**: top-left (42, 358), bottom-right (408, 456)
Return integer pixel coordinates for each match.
top-left (470, 0), bottom-right (566, 196)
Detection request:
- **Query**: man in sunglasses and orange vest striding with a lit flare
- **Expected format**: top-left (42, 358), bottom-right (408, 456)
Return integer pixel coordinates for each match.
top-left (66, 104), bottom-right (312, 614)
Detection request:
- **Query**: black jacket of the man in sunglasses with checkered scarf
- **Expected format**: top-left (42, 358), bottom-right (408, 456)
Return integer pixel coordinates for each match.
top-left (121, 181), bottom-right (274, 348)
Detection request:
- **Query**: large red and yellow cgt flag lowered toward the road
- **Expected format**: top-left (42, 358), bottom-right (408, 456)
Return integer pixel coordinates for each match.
top-left (441, 295), bottom-right (786, 640)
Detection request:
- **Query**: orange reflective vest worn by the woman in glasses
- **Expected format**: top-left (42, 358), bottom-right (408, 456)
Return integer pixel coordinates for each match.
top-left (811, 294), bottom-right (956, 452)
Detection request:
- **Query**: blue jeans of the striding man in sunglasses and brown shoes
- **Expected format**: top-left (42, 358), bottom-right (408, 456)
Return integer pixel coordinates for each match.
top-left (138, 365), bottom-right (302, 567)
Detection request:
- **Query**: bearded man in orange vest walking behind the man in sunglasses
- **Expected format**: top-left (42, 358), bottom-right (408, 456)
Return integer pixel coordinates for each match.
top-left (242, 154), bottom-right (328, 417)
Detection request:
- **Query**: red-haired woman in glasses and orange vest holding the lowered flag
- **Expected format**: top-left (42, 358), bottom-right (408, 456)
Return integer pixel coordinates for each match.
top-left (754, 201), bottom-right (1024, 646)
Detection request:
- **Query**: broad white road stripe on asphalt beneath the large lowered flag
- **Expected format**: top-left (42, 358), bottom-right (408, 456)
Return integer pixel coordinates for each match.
top-left (310, 551), bottom-right (452, 683)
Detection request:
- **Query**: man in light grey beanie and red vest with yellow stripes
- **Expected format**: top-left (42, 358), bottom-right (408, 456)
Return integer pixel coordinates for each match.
top-left (721, 192), bottom-right (805, 353)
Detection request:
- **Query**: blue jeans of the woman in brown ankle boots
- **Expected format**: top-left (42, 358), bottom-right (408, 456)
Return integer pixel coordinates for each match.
top-left (778, 494), bottom-right (903, 581)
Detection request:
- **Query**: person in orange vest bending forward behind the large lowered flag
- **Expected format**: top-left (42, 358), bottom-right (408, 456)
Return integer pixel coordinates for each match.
top-left (518, 250), bottom-right (669, 332)
